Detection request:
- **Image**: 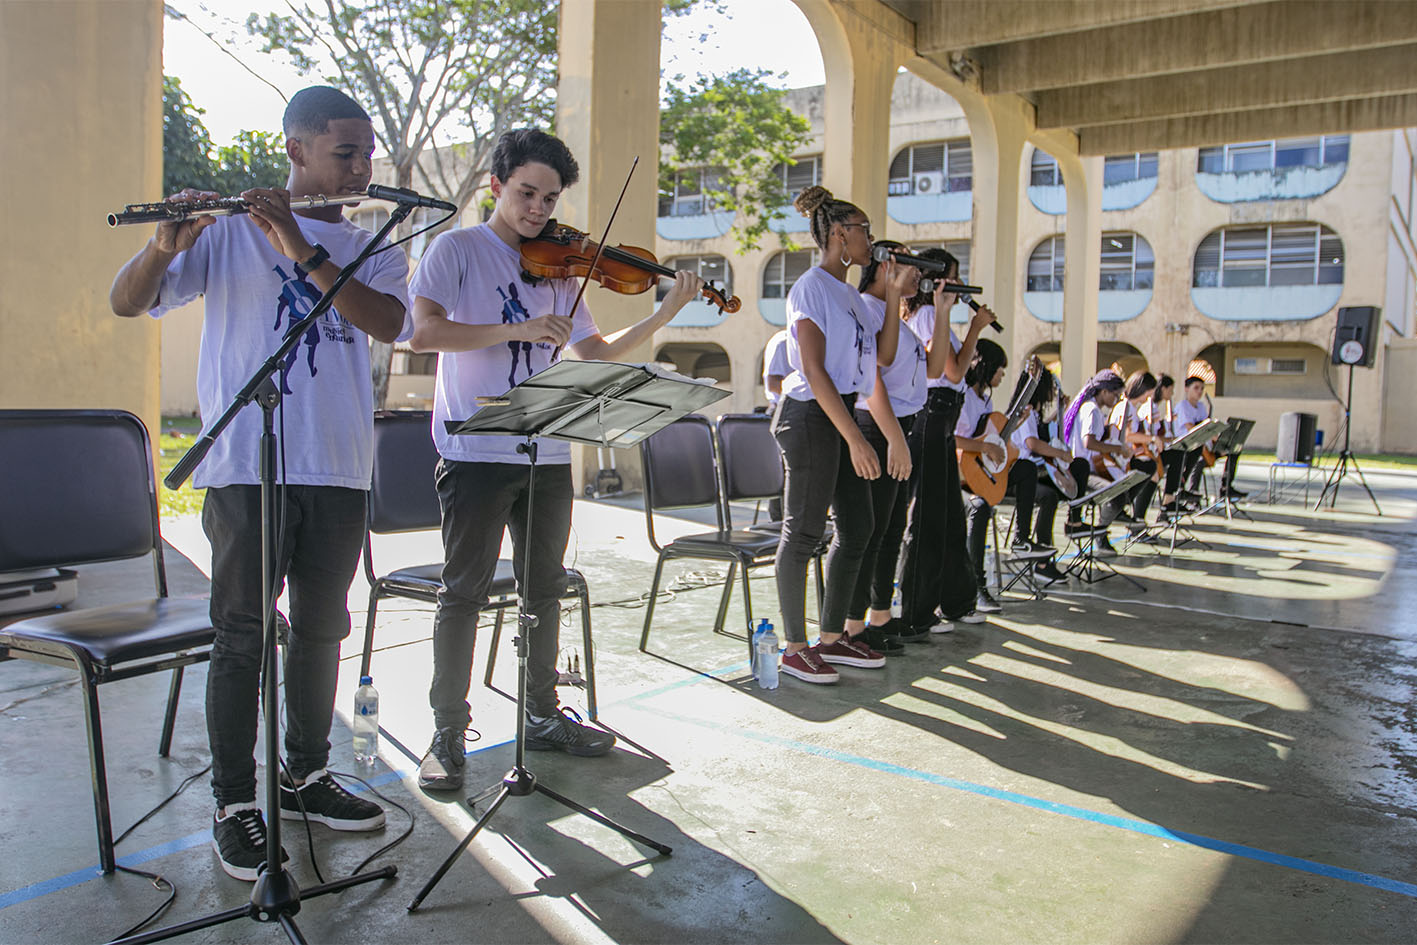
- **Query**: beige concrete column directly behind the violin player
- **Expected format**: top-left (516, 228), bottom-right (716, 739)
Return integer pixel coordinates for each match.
top-left (555, 0), bottom-right (660, 490)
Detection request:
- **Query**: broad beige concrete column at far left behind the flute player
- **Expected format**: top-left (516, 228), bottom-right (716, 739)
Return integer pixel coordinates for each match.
top-left (0, 0), bottom-right (163, 431)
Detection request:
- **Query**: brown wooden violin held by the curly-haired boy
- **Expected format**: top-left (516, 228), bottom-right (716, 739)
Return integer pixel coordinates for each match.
top-left (521, 220), bottom-right (743, 315)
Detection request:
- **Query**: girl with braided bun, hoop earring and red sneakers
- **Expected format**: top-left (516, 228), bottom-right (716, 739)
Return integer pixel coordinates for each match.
top-left (772, 186), bottom-right (900, 683)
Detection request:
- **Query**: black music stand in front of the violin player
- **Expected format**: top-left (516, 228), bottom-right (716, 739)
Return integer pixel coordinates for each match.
top-left (408, 361), bottom-right (728, 912)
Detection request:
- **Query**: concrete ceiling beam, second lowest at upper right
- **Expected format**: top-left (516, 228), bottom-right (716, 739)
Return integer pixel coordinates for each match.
top-left (1034, 43), bottom-right (1417, 128)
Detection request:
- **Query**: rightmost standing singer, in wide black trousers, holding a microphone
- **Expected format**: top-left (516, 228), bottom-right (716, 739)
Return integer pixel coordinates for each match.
top-left (900, 249), bottom-right (993, 638)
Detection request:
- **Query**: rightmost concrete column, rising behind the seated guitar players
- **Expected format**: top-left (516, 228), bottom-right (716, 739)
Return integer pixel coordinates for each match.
top-left (1050, 149), bottom-right (1102, 394)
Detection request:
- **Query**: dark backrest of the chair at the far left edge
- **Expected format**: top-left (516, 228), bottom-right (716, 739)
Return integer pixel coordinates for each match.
top-left (0, 409), bottom-right (167, 595)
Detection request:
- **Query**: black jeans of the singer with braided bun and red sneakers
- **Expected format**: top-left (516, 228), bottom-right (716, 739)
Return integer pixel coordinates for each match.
top-left (772, 395), bottom-right (874, 643)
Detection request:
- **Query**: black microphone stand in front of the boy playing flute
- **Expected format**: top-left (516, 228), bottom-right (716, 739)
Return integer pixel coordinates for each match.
top-left (109, 203), bottom-right (414, 945)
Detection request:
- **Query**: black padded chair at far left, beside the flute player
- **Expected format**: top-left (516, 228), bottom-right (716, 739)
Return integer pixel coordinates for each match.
top-left (0, 409), bottom-right (215, 873)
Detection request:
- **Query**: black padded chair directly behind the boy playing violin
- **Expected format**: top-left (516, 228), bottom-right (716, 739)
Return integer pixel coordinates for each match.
top-left (360, 411), bottom-right (597, 721)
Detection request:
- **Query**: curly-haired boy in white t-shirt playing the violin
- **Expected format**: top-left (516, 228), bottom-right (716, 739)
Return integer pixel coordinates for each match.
top-left (410, 129), bottom-right (703, 791)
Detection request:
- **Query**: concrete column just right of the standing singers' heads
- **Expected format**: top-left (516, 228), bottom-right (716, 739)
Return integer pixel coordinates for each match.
top-left (961, 96), bottom-right (1032, 364)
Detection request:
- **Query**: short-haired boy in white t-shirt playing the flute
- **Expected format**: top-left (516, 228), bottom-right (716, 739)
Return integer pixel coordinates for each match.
top-left (109, 86), bottom-right (411, 880)
